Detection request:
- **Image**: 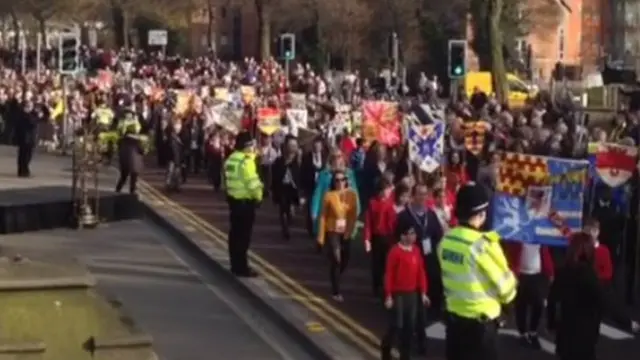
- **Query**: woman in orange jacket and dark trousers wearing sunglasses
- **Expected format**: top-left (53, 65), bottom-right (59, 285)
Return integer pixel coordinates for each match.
top-left (318, 171), bottom-right (358, 301)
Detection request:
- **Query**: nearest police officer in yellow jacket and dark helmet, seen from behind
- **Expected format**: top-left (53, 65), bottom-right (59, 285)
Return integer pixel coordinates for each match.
top-left (438, 183), bottom-right (516, 360)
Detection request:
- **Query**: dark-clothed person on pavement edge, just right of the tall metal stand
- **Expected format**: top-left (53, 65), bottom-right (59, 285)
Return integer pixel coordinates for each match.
top-left (116, 124), bottom-right (145, 194)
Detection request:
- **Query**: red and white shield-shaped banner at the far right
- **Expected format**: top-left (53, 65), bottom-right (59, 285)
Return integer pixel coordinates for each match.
top-left (588, 143), bottom-right (638, 188)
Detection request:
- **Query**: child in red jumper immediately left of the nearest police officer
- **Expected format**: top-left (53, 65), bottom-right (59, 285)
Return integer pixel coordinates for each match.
top-left (380, 222), bottom-right (429, 360)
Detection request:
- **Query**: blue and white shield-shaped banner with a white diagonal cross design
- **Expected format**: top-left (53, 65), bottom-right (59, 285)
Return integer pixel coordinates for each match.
top-left (407, 121), bottom-right (445, 173)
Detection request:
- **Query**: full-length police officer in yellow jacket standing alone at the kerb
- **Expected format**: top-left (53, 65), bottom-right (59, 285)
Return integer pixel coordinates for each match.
top-left (224, 132), bottom-right (263, 277)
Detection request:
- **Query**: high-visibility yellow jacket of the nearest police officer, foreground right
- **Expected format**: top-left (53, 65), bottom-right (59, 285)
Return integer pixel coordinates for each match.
top-left (438, 226), bottom-right (517, 319)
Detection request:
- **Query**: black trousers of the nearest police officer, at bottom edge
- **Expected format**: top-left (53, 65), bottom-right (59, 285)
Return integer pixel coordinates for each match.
top-left (446, 313), bottom-right (498, 360)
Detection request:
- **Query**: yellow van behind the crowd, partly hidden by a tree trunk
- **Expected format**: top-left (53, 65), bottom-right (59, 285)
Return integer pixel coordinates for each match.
top-left (464, 71), bottom-right (536, 108)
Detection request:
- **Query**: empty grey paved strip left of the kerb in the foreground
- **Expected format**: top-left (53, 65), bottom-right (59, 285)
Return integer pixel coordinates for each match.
top-left (0, 221), bottom-right (314, 360)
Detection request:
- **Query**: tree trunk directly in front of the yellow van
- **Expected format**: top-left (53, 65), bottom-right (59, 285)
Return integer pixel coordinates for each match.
top-left (488, 0), bottom-right (509, 103)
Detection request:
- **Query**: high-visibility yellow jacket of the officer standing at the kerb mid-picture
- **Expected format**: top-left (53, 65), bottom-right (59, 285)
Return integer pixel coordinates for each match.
top-left (224, 151), bottom-right (263, 201)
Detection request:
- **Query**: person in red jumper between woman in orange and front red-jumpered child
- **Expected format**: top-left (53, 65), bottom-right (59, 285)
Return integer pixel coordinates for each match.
top-left (364, 178), bottom-right (395, 296)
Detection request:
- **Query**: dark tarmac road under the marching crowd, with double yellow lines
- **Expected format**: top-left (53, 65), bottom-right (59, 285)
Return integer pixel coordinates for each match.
top-left (142, 166), bottom-right (640, 360)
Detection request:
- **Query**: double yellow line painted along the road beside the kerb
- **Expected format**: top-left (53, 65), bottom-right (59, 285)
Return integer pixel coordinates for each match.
top-left (140, 182), bottom-right (380, 358)
